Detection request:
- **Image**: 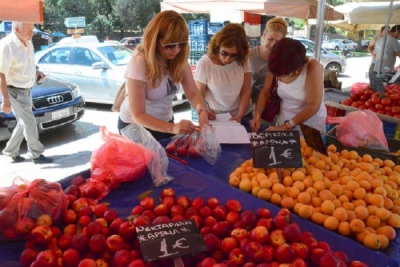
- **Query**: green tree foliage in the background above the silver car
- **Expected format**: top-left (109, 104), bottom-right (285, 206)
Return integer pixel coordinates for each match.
top-left (37, 0), bottom-right (209, 40)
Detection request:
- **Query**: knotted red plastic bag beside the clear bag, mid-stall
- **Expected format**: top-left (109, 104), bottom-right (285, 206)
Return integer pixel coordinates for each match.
top-left (90, 126), bottom-right (154, 184)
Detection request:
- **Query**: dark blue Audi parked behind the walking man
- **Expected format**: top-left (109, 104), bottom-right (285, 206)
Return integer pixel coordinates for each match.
top-left (0, 77), bottom-right (85, 141)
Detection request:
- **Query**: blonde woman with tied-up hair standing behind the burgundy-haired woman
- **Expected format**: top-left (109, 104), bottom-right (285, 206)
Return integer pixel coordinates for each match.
top-left (249, 17), bottom-right (287, 129)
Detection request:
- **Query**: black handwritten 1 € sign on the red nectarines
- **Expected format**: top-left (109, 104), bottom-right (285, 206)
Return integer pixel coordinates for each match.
top-left (136, 220), bottom-right (207, 261)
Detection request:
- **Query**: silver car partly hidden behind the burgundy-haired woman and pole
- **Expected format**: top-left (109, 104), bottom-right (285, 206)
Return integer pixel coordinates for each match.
top-left (293, 38), bottom-right (346, 73)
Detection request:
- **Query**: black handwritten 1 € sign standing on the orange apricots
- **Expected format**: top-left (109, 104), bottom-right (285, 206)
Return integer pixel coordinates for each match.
top-left (250, 131), bottom-right (303, 168)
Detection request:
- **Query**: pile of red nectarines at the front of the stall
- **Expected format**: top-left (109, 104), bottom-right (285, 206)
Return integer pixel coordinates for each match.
top-left (20, 184), bottom-right (367, 267)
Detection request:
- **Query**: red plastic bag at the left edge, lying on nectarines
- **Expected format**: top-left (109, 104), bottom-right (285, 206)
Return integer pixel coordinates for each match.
top-left (0, 177), bottom-right (69, 240)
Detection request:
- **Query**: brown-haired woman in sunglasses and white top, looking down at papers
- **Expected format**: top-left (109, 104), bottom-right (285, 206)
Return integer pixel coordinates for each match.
top-left (194, 23), bottom-right (252, 128)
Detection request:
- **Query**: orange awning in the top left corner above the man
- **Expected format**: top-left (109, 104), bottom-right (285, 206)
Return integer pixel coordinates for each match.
top-left (0, 0), bottom-right (44, 23)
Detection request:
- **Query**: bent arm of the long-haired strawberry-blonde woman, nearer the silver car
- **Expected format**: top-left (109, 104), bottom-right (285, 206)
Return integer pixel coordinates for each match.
top-left (126, 78), bottom-right (195, 134)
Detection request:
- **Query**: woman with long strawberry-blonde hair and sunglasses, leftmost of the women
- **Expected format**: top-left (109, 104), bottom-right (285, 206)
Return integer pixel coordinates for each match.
top-left (118, 11), bottom-right (208, 140)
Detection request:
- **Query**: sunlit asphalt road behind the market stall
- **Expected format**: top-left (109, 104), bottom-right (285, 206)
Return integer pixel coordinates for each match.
top-left (0, 57), bottom-right (388, 187)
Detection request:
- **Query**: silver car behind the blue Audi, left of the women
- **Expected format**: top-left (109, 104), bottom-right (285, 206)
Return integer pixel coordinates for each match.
top-left (35, 43), bottom-right (132, 104)
